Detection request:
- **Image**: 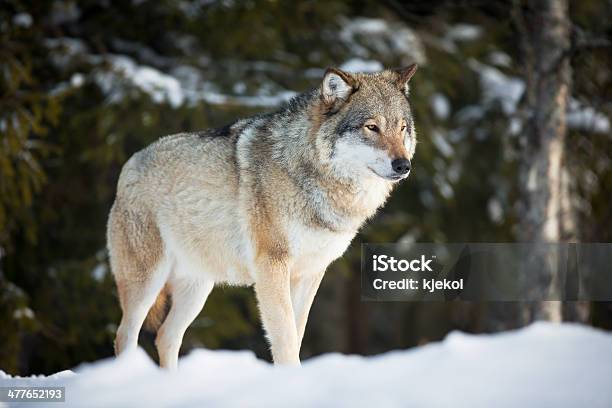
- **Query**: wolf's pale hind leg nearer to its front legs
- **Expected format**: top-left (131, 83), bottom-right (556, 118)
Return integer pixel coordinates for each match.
top-left (155, 278), bottom-right (214, 370)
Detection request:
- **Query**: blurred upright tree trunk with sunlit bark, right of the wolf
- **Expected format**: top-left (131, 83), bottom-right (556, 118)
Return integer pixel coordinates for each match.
top-left (515, 0), bottom-right (588, 321)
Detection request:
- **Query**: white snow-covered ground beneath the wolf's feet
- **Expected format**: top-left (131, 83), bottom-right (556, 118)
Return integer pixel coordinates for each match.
top-left (0, 323), bottom-right (612, 407)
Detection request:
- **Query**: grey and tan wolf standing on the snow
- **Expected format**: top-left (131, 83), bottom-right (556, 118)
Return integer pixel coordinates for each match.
top-left (107, 64), bottom-right (417, 369)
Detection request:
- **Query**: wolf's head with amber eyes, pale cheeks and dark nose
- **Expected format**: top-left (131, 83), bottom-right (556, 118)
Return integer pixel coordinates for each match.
top-left (318, 64), bottom-right (417, 181)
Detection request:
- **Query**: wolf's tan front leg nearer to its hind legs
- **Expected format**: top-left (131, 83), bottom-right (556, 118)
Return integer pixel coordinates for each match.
top-left (255, 259), bottom-right (300, 364)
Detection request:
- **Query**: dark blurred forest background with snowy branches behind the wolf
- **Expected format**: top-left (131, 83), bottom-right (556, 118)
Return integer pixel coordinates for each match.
top-left (0, 0), bottom-right (612, 375)
